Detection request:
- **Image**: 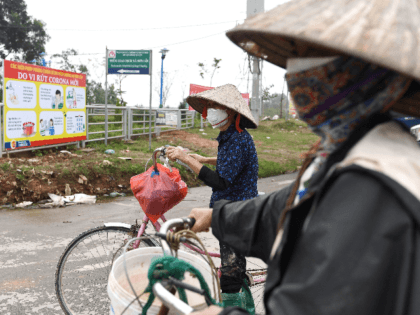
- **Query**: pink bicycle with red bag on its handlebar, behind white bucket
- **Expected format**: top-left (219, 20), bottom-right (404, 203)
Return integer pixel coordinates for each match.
top-left (55, 147), bottom-right (267, 315)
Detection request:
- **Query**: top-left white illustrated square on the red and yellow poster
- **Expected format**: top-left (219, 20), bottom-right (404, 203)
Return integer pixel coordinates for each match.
top-left (6, 80), bottom-right (36, 108)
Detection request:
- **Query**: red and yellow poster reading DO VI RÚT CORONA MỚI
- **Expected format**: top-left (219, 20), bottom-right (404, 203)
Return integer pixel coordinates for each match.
top-left (3, 60), bottom-right (86, 150)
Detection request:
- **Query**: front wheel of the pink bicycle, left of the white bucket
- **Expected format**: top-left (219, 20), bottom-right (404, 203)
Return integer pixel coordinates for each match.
top-left (55, 226), bottom-right (159, 315)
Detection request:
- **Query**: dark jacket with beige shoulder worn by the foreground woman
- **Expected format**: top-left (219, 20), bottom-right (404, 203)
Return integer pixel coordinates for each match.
top-left (212, 116), bottom-right (420, 315)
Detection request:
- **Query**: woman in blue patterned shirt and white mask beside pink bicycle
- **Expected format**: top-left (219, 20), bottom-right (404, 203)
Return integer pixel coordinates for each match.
top-left (167, 84), bottom-right (258, 302)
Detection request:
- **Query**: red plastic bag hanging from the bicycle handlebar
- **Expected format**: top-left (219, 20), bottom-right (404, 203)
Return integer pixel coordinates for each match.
top-left (130, 164), bottom-right (188, 223)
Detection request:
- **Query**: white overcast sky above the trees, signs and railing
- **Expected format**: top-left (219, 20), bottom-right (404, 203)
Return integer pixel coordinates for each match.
top-left (26, 0), bottom-right (286, 107)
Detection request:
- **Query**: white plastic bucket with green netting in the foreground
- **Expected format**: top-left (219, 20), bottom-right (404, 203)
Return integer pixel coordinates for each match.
top-left (108, 247), bottom-right (214, 315)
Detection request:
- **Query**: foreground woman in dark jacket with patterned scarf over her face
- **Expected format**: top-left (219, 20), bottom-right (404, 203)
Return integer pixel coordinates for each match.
top-left (191, 0), bottom-right (420, 315)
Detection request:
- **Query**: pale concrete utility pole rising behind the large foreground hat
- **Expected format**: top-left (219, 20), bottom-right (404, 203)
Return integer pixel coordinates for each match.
top-left (246, 0), bottom-right (264, 123)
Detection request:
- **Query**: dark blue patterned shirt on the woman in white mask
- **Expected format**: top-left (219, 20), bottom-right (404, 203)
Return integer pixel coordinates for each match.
top-left (210, 123), bottom-right (258, 208)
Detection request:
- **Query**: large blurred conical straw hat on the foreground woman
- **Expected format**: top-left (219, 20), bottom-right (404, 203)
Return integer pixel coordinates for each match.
top-left (227, 0), bottom-right (420, 116)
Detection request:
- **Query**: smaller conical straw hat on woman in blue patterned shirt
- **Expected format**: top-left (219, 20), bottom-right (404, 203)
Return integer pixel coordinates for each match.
top-left (187, 84), bottom-right (257, 128)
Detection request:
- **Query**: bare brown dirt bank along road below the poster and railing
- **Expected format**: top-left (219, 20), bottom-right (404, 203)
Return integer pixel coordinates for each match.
top-left (0, 130), bottom-right (218, 205)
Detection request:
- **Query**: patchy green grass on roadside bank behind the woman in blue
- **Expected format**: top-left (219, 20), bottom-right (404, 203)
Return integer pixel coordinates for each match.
top-left (85, 119), bottom-right (318, 184)
